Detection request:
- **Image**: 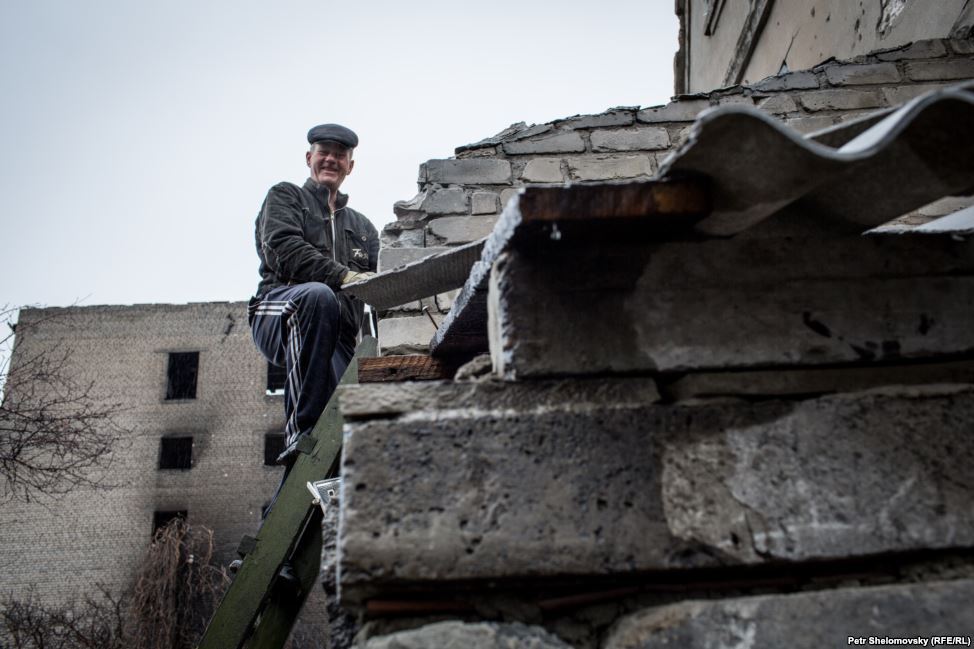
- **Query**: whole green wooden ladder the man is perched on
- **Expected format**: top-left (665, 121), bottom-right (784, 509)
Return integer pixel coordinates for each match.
top-left (198, 337), bottom-right (376, 649)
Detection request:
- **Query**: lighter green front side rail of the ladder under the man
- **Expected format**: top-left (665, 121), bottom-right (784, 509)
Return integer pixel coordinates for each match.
top-left (198, 338), bottom-right (376, 649)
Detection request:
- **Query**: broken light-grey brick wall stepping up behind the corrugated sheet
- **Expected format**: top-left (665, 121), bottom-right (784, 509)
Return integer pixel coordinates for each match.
top-left (379, 39), bottom-right (974, 354)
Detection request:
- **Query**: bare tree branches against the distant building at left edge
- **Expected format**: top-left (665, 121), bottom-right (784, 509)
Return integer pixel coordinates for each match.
top-left (0, 308), bottom-right (128, 501)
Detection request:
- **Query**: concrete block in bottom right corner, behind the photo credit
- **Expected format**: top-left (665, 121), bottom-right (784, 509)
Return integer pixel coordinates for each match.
top-left (603, 579), bottom-right (974, 649)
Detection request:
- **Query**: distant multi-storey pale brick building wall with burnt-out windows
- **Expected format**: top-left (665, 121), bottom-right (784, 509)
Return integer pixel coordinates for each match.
top-left (0, 302), bottom-right (283, 602)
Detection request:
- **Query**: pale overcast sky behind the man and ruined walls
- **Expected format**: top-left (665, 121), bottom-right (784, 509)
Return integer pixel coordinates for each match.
top-left (0, 0), bottom-right (677, 306)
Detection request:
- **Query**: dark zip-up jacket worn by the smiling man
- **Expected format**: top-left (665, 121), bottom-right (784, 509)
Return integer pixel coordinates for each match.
top-left (254, 178), bottom-right (379, 337)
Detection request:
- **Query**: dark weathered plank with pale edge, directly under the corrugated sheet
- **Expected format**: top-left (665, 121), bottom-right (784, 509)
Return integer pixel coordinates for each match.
top-left (430, 180), bottom-right (711, 358)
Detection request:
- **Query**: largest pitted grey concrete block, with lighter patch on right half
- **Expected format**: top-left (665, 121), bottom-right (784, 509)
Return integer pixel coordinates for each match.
top-left (339, 383), bottom-right (974, 605)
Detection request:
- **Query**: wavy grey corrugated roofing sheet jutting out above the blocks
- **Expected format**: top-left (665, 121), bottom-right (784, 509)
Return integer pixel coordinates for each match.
top-left (660, 83), bottom-right (974, 236)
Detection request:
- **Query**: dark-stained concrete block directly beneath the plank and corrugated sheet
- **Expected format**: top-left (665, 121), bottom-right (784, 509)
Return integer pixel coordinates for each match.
top-left (488, 237), bottom-right (974, 378)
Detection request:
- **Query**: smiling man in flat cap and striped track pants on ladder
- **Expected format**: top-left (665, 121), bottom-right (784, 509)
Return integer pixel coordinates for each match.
top-left (249, 124), bottom-right (379, 469)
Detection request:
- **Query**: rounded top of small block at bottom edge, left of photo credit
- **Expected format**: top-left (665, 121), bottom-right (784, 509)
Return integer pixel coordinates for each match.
top-left (356, 621), bottom-right (572, 649)
